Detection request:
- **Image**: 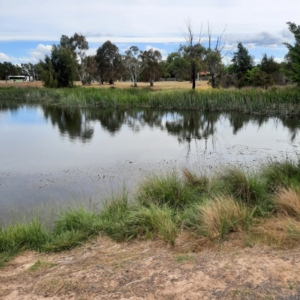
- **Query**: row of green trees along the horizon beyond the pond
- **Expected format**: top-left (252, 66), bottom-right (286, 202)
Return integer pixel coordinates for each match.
top-left (0, 22), bottom-right (300, 88)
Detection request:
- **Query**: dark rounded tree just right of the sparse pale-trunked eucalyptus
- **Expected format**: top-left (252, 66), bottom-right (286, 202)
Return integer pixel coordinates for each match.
top-left (141, 48), bottom-right (162, 86)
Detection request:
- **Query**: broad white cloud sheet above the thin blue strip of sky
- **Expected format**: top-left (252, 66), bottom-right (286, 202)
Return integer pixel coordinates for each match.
top-left (0, 0), bottom-right (300, 42)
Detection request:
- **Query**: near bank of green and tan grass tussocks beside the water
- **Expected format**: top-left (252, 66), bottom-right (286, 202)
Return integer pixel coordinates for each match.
top-left (0, 161), bottom-right (300, 264)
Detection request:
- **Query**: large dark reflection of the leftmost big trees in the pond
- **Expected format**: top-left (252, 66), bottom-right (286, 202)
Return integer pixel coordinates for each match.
top-left (42, 105), bottom-right (94, 143)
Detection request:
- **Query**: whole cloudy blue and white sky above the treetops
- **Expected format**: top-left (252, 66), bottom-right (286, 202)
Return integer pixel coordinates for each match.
top-left (0, 0), bottom-right (300, 64)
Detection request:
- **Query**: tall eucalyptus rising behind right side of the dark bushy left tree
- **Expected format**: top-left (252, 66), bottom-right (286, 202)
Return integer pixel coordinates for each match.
top-left (60, 32), bottom-right (89, 85)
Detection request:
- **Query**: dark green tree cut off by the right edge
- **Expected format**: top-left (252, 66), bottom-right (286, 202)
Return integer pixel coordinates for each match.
top-left (285, 22), bottom-right (300, 86)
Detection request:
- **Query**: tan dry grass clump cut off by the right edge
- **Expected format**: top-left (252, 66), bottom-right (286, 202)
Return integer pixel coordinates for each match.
top-left (275, 188), bottom-right (300, 221)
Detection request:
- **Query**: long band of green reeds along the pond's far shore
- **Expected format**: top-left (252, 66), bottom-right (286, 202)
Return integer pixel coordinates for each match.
top-left (0, 87), bottom-right (300, 116)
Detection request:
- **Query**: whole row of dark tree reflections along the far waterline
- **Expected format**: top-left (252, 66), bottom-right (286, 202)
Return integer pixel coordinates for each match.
top-left (0, 101), bottom-right (300, 144)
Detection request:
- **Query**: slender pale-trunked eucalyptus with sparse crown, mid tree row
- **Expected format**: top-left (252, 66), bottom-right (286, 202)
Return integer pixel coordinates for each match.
top-left (123, 46), bottom-right (145, 87)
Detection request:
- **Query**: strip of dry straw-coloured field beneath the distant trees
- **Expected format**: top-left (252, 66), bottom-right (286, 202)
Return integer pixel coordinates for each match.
top-left (0, 80), bottom-right (210, 90)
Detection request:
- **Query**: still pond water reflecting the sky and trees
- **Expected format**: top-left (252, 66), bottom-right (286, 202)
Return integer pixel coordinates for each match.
top-left (0, 101), bottom-right (300, 222)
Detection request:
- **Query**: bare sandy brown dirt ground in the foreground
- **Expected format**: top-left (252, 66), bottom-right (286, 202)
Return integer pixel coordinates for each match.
top-left (0, 236), bottom-right (300, 300)
